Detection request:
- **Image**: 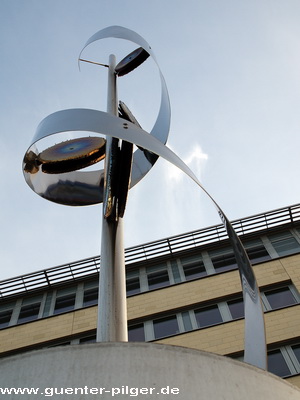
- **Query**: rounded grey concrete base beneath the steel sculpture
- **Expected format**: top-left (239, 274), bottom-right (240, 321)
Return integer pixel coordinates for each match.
top-left (0, 343), bottom-right (300, 400)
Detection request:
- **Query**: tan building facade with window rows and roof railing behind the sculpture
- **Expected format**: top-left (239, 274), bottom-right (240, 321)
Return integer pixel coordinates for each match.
top-left (0, 204), bottom-right (300, 387)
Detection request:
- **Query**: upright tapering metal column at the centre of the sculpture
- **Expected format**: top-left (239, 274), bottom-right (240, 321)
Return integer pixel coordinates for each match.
top-left (97, 55), bottom-right (128, 342)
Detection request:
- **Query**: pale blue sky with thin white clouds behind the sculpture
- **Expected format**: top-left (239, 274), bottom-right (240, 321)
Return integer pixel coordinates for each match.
top-left (0, 0), bottom-right (300, 280)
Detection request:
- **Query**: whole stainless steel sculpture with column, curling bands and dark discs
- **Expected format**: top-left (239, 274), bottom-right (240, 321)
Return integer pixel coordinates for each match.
top-left (23, 26), bottom-right (266, 369)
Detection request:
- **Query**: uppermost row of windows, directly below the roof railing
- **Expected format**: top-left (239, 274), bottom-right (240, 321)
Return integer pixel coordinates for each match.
top-left (0, 230), bottom-right (300, 329)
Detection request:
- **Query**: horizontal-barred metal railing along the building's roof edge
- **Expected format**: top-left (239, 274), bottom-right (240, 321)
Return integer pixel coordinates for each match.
top-left (0, 204), bottom-right (300, 299)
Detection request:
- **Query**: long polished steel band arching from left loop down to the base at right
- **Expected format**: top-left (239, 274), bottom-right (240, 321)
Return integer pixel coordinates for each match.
top-left (24, 109), bottom-right (266, 369)
